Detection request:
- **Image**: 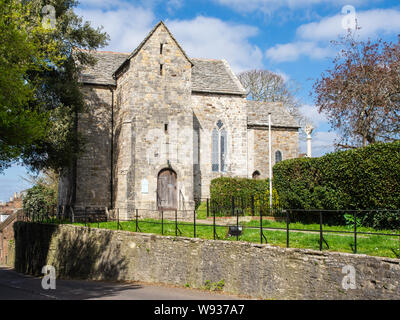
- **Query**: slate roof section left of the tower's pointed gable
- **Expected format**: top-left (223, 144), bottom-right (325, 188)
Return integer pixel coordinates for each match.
top-left (81, 51), bottom-right (129, 85)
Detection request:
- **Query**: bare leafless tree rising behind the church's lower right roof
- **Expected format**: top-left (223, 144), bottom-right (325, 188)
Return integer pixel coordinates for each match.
top-left (238, 70), bottom-right (309, 128)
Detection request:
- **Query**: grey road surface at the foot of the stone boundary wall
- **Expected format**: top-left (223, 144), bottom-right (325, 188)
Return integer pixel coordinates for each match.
top-left (0, 266), bottom-right (243, 300)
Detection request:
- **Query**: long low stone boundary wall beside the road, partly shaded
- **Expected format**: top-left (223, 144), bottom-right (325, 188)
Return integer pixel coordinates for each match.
top-left (8, 222), bottom-right (400, 300)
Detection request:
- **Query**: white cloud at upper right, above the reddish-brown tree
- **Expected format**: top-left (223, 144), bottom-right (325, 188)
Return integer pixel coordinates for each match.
top-left (266, 9), bottom-right (400, 63)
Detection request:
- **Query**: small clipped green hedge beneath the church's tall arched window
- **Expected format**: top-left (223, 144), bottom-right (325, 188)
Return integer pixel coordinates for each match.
top-left (210, 178), bottom-right (279, 215)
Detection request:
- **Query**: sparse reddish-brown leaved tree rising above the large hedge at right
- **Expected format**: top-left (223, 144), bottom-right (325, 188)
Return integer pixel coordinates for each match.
top-left (314, 32), bottom-right (400, 148)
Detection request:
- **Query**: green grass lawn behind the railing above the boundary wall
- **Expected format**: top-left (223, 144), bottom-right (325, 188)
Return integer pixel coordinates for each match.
top-left (76, 214), bottom-right (400, 258)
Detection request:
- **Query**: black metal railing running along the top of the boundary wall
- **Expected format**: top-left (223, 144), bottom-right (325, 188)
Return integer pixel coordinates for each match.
top-left (18, 204), bottom-right (400, 258)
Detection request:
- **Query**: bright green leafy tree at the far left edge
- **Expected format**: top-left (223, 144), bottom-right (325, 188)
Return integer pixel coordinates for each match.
top-left (0, 0), bottom-right (54, 171)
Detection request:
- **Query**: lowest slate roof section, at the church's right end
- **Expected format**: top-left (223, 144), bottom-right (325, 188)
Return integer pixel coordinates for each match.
top-left (247, 101), bottom-right (300, 128)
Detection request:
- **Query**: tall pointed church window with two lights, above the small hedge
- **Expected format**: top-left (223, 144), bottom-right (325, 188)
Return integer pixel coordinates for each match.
top-left (211, 120), bottom-right (228, 172)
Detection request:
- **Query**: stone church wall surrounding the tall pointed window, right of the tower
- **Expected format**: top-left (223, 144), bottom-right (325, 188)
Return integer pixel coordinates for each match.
top-left (191, 93), bottom-right (248, 198)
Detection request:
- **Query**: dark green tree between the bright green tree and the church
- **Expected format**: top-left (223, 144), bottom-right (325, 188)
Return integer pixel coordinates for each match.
top-left (22, 0), bottom-right (108, 171)
